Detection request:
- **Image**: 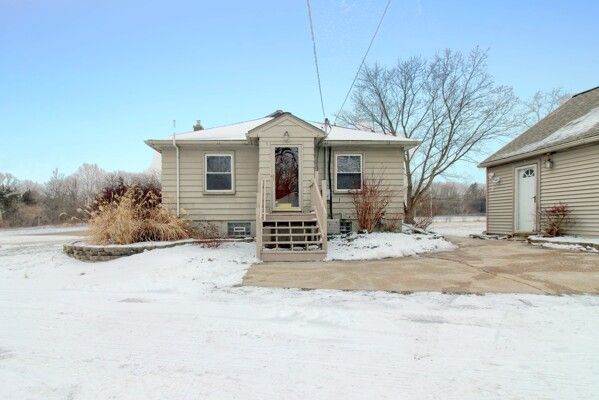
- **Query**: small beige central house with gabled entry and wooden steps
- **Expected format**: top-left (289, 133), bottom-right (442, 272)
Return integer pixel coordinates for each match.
top-left (146, 111), bottom-right (418, 261)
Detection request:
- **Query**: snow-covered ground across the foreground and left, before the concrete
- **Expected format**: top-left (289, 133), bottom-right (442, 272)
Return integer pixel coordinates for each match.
top-left (0, 230), bottom-right (599, 400)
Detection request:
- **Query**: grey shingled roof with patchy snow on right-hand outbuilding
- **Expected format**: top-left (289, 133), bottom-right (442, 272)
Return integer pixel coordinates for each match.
top-left (479, 86), bottom-right (599, 167)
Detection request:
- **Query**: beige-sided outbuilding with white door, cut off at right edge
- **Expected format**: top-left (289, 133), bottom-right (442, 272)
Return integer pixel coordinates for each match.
top-left (479, 87), bottom-right (599, 236)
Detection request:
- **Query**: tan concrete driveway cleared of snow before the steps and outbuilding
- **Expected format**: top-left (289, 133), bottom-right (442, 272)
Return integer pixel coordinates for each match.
top-left (243, 238), bottom-right (599, 294)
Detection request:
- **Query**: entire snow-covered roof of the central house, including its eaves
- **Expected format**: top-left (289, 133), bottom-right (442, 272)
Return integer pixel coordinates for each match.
top-left (146, 110), bottom-right (419, 147)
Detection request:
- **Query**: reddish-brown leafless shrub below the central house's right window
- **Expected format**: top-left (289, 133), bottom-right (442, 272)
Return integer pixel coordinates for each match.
top-left (351, 176), bottom-right (393, 232)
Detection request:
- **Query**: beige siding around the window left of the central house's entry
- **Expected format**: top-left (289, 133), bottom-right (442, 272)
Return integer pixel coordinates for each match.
top-left (162, 145), bottom-right (258, 221)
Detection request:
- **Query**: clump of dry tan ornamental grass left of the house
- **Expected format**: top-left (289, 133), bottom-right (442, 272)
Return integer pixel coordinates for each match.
top-left (89, 185), bottom-right (192, 244)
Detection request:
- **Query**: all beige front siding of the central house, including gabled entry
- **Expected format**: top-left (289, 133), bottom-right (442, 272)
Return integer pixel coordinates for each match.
top-left (157, 117), bottom-right (404, 230)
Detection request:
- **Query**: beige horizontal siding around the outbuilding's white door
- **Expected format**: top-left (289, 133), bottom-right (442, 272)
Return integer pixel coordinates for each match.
top-left (487, 145), bottom-right (599, 236)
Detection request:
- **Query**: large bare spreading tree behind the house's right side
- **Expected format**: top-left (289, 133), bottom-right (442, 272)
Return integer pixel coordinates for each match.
top-left (339, 47), bottom-right (519, 223)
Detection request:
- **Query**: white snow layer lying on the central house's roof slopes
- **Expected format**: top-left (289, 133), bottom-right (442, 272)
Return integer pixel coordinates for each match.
top-left (159, 113), bottom-right (406, 142)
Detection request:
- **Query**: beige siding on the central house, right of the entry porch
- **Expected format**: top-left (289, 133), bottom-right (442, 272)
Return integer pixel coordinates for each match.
top-left (318, 146), bottom-right (405, 219)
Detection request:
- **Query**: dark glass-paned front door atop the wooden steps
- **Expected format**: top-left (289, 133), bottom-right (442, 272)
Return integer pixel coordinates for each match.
top-left (274, 146), bottom-right (300, 211)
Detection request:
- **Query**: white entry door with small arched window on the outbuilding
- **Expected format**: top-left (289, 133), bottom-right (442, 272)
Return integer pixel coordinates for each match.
top-left (515, 165), bottom-right (537, 232)
